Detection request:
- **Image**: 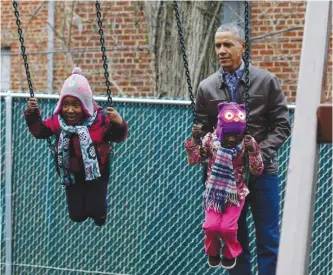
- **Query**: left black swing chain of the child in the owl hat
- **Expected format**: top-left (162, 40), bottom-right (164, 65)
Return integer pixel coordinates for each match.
top-left (173, 0), bottom-right (205, 156)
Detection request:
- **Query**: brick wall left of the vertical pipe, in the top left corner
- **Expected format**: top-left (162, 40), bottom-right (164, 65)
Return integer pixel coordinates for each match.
top-left (1, 1), bottom-right (47, 90)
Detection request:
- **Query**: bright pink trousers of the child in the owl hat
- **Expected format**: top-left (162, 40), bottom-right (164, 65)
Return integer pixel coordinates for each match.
top-left (202, 200), bottom-right (244, 259)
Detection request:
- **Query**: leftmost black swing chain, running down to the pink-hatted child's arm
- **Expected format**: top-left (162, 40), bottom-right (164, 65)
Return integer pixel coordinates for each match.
top-left (13, 1), bottom-right (56, 158)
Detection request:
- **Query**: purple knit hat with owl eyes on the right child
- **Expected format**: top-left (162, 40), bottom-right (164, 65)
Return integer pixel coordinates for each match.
top-left (216, 102), bottom-right (246, 142)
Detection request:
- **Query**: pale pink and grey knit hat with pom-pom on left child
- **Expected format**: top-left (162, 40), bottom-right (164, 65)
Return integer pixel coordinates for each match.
top-left (54, 67), bottom-right (94, 116)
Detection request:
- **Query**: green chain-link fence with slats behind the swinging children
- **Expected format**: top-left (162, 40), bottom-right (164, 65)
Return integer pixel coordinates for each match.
top-left (0, 95), bottom-right (332, 275)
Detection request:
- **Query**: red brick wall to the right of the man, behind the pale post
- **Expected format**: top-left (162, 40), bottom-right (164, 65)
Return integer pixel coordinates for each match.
top-left (251, 1), bottom-right (332, 102)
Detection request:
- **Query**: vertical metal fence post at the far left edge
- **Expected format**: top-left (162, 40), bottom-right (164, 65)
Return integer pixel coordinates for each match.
top-left (5, 92), bottom-right (12, 275)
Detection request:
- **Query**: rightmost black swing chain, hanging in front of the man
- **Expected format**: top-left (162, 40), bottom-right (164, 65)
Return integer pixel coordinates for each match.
top-left (243, 1), bottom-right (250, 185)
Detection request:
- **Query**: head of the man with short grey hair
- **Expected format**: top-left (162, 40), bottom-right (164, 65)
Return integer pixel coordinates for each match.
top-left (215, 32), bottom-right (245, 73)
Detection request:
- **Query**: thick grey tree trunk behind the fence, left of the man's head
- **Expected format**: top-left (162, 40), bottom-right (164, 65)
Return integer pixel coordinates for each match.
top-left (143, 1), bottom-right (222, 98)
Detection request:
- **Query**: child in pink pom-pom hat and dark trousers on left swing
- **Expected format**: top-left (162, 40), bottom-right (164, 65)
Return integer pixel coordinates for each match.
top-left (24, 68), bottom-right (127, 226)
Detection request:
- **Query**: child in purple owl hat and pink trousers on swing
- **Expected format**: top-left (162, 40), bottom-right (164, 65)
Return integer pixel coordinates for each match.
top-left (185, 102), bottom-right (264, 269)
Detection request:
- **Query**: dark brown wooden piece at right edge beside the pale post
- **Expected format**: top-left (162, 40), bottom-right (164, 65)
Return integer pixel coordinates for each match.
top-left (317, 104), bottom-right (332, 144)
